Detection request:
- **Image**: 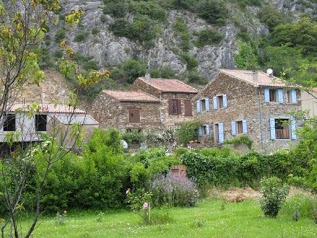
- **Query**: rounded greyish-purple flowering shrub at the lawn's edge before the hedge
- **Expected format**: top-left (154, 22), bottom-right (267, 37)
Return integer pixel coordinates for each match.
top-left (151, 173), bottom-right (199, 207)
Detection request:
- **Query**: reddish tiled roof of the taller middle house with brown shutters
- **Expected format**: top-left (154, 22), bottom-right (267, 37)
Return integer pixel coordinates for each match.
top-left (139, 77), bottom-right (198, 93)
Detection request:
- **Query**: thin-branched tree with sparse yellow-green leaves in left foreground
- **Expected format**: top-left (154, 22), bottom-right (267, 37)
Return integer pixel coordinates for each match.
top-left (0, 0), bottom-right (109, 237)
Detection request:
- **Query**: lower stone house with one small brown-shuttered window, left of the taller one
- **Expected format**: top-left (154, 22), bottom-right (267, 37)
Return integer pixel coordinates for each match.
top-left (92, 90), bottom-right (161, 131)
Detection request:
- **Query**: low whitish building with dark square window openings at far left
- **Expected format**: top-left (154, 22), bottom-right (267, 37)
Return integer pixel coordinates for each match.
top-left (0, 103), bottom-right (99, 146)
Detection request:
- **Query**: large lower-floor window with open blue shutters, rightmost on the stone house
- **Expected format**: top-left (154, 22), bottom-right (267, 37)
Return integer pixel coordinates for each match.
top-left (270, 118), bottom-right (296, 140)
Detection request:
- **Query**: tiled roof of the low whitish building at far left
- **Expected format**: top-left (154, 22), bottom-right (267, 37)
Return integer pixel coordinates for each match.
top-left (9, 103), bottom-right (85, 114)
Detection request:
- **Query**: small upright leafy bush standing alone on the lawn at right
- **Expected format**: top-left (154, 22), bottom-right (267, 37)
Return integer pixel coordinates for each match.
top-left (260, 177), bottom-right (289, 218)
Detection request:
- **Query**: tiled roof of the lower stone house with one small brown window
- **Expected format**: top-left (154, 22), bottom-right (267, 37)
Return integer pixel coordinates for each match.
top-left (102, 90), bottom-right (160, 102)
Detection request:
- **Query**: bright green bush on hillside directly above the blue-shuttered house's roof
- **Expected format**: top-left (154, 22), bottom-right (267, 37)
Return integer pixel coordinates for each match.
top-left (234, 41), bottom-right (259, 70)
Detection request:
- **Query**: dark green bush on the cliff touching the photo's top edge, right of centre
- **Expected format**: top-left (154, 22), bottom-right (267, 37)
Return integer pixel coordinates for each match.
top-left (197, 0), bottom-right (228, 26)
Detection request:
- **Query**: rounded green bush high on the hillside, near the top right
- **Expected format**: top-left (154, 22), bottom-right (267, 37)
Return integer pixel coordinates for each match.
top-left (258, 4), bottom-right (287, 32)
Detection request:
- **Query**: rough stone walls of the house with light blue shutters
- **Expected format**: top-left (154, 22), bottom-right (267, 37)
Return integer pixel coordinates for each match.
top-left (194, 73), bottom-right (301, 152)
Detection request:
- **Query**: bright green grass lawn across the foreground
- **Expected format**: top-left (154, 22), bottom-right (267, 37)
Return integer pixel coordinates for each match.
top-left (17, 200), bottom-right (317, 238)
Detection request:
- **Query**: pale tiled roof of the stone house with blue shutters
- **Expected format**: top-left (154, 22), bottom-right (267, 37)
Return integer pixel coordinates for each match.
top-left (220, 69), bottom-right (294, 87)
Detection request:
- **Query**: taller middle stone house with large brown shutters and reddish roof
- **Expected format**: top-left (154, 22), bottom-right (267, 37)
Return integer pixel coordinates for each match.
top-left (129, 77), bottom-right (198, 129)
